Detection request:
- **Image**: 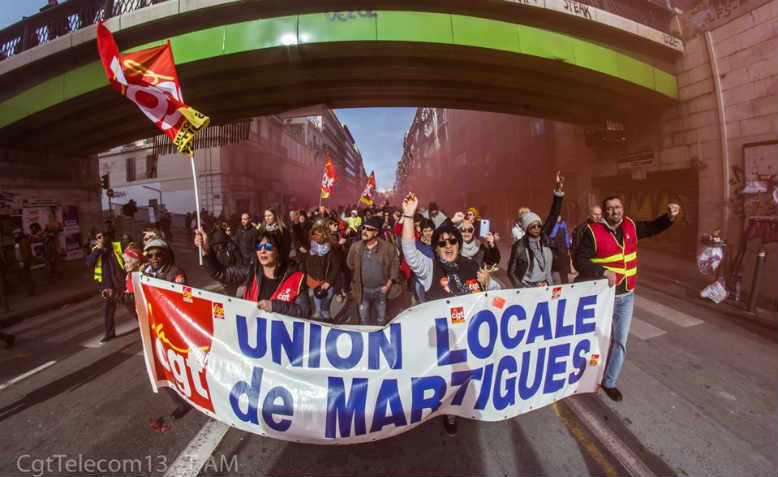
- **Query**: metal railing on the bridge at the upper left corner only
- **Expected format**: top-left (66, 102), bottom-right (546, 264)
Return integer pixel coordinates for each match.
top-left (0, 0), bottom-right (167, 61)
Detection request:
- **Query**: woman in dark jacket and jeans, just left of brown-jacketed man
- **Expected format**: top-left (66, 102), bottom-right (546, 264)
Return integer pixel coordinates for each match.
top-left (300, 218), bottom-right (343, 321)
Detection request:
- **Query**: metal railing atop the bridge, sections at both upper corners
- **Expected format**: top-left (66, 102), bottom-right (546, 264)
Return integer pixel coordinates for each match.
top-left (0, 0), bottom-right (674, 61)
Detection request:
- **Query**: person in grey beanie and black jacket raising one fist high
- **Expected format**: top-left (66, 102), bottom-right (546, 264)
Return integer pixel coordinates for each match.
top-left (508, 172), bottom-right (565, 288)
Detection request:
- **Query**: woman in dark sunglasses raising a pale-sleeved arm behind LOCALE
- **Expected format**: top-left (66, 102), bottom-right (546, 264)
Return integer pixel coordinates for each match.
top-left (402, 193), bottom-right (500, 436)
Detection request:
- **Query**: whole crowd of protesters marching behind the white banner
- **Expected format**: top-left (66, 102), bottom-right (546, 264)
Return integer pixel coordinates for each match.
top-left (73, 173), bottom-right (679, 435)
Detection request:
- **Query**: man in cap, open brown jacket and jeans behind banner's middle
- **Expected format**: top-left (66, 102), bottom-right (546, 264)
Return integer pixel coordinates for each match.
top-left (346, 217), bottom-right (402, 326)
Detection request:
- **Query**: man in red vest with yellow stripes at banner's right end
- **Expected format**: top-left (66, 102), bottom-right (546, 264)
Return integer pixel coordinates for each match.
top-left (574, 196), bottom-right (681, 401)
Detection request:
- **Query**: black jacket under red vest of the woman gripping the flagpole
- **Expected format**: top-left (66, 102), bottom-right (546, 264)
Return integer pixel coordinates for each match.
top-left (203, 253), bottom-right (311, 318)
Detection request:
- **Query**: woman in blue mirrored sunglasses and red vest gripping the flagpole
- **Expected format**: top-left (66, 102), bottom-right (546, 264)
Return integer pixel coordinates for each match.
top-left (194, 229), bottom-right (311, 318)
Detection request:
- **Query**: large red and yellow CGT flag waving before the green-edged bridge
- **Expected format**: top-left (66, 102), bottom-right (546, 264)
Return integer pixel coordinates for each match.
top-left (97, 22), bottom-right (210, 154)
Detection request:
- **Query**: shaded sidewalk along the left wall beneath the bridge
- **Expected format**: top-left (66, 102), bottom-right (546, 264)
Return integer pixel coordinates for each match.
top-left (0, 259), bottom-right (97, 328)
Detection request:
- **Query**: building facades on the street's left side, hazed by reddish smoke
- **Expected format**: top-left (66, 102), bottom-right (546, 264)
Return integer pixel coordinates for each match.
top-left (99, 113), bottom-right (364, 217)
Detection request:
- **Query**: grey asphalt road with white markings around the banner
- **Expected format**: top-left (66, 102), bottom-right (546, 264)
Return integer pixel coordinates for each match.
top-left (0, 244), bottom-right (778, 476)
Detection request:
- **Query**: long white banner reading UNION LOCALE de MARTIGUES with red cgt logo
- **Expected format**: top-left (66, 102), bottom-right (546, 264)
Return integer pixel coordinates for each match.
top-left (133, 273), bottom-right (614, 444)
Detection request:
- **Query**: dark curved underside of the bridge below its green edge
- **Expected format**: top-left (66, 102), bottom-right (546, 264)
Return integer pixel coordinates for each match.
top-left (0, 42), bottom-right (671, 155)
